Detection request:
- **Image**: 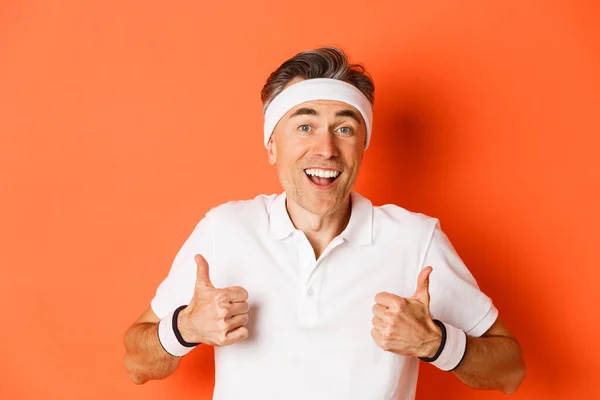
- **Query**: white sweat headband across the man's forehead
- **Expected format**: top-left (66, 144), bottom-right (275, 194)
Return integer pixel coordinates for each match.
top-left (264, 78), bottom-right (373, 149)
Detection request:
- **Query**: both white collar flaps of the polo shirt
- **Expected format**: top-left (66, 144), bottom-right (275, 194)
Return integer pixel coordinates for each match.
top-left (269, 191), bottom-right (373, 245)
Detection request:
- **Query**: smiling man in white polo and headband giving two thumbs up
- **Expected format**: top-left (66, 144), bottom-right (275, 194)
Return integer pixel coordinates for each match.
top-left (125, 47), bottom-right (525, 400)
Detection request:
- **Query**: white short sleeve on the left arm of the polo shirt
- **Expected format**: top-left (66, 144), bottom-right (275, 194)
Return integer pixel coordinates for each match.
top-left (150, 211), bottom-right (215, 318)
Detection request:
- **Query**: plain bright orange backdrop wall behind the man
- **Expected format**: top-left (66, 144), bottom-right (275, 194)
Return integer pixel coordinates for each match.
top-left (0, 0), bottom-right (600, 400)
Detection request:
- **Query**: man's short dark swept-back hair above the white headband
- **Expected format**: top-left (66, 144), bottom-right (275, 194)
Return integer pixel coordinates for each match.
top-left (260, 46), bottom-right (375, 113)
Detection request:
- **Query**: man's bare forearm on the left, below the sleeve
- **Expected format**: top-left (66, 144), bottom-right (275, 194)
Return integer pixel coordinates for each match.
top-left (124, 322), bottom-right (181, 384)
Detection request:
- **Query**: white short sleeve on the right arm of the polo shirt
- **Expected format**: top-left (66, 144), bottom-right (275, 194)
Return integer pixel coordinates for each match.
top-left (421, 219), bottom-right (498, 337)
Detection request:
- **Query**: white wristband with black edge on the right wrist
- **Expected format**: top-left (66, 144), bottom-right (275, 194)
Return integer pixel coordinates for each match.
top-left (419, 319), bottom-right (467, 371)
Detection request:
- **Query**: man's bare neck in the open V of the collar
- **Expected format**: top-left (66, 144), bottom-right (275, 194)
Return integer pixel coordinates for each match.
top-left (286, 195), bottom-right (351, 258)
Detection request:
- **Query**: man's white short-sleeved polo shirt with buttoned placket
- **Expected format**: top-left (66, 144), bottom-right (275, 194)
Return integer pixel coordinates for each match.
top-left (151, 192), bottom-right (498, 400)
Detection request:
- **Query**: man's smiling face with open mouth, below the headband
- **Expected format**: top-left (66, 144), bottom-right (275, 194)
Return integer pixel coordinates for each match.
top-left (268, 80), bottom-right (366, 216)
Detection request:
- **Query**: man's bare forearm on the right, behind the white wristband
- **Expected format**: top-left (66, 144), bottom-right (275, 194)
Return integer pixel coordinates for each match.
top-left (453, 336), bottom-right (525, 394)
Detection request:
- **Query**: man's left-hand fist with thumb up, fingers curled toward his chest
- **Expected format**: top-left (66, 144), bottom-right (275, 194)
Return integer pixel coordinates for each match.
top-left (177, 254), bottom-right (249, 346)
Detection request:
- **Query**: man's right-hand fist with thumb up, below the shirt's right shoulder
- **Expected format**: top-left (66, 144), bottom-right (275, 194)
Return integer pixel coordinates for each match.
top-left (371, 267), bottom-right (441, 357)
